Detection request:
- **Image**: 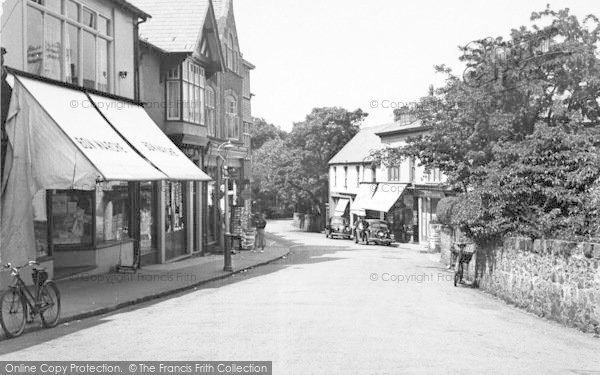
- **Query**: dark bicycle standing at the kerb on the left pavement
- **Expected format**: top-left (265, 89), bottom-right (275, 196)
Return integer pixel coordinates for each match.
top-left (0, 261), bottom-right (60, 338)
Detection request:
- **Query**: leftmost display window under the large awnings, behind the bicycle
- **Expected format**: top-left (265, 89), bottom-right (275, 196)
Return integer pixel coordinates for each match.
top-left (51, 190), bottom-right (94, 247)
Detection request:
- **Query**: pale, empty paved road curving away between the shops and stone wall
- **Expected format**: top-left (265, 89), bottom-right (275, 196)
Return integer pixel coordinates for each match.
top-left (0, 221), bottom-right (600, 375)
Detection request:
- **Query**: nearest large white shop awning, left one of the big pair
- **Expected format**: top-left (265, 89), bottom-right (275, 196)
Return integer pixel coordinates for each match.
top-left (16, 76), bottom-right (167, 183)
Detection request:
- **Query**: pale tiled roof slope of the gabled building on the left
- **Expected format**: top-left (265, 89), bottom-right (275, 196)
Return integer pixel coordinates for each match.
top-left (130, 0), bottom-right (210, 52)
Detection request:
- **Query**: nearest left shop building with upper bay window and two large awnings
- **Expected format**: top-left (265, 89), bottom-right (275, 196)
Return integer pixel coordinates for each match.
top-left (0, 0), bottom-right (209, 286)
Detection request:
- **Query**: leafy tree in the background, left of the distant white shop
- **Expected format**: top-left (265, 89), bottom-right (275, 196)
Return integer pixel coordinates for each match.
top-left (252, 107), bottom-right (367, 214)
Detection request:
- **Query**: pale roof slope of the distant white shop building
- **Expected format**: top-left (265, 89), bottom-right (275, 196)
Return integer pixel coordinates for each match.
top-left (329, 124), bottom-right (390, 164)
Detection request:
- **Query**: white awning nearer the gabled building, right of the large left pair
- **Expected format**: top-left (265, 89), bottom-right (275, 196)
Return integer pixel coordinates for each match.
top-left (89, 95), bottom-right (211, 181)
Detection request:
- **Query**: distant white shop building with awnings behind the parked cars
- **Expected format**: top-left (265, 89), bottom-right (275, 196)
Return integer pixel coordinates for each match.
top-left (329, 120), bottom-right (448, 243)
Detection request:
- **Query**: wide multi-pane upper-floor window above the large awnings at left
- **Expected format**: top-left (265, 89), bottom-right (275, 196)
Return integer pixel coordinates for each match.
top-left (26, 0), bottom-right (112, 92)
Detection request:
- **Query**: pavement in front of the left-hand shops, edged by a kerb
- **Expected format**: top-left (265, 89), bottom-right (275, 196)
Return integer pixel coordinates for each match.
top-left (0, 236), bottom-right (289, 339)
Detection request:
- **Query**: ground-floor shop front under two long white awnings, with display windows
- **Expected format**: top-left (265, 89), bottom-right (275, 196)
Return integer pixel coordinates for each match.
top-left (0, 72), bottom-right (209, 284)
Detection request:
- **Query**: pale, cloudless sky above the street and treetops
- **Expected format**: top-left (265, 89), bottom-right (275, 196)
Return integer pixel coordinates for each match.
top-left (234, 0), bottom-right (600, 130)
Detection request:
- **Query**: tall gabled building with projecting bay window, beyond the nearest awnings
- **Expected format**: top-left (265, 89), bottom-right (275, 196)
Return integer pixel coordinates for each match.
top-left (134, 0), bottom-right (254, 261)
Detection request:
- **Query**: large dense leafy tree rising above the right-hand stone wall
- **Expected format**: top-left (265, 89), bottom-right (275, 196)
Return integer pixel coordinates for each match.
top-left (382, 8), bottom-right (600, 242)
